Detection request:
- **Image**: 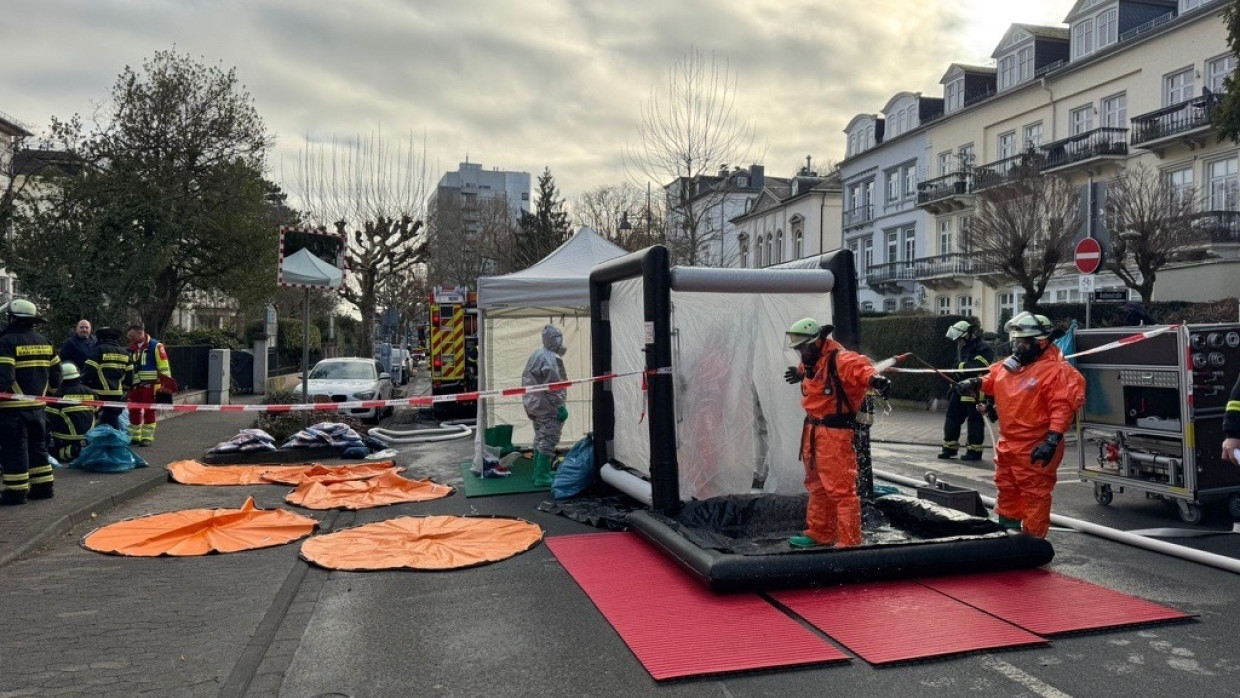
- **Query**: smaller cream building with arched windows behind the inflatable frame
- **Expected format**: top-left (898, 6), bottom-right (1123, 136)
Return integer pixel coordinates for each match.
top-left (732, 161), bottom-right (842, 268)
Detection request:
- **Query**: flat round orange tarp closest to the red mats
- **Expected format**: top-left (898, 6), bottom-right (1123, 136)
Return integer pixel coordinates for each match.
top-left (301, 516), bottom-right (542, 572)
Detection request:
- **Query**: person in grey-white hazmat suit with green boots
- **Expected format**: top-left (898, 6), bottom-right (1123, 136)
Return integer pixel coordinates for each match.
top-left (521, 325), bottom-right (568, 487)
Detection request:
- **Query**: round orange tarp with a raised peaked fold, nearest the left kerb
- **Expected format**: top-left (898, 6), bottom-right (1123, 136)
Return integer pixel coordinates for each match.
top-left (82, 497), bottom-right (319, 558)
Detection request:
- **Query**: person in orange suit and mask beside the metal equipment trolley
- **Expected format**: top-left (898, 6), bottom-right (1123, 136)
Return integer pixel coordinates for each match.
top-left (956, 311), bottom-right (1085, 538)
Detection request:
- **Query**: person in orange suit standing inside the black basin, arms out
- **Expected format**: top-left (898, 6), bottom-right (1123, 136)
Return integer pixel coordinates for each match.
top-left (784, 317), bottom-right (892, 548)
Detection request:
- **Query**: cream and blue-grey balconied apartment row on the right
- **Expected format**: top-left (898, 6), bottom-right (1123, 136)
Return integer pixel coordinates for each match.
top-left (841, 0), bottom-right (1240, 326)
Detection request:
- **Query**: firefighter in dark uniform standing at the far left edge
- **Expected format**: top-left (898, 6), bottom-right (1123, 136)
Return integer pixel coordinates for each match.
top-left (0, 299), bottom-right (61, 505)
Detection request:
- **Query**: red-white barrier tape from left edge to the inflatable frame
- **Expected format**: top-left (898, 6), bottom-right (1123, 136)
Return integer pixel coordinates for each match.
top-left (0, 367), bottom-right (672, 413)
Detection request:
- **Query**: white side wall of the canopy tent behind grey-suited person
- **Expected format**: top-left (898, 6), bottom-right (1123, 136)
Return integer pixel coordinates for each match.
top-left (479, 307), bottom-right (594, 448)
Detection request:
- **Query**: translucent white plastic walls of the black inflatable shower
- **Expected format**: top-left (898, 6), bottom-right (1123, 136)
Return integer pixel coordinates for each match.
top-left (609, 279), bottom-right (831, 500)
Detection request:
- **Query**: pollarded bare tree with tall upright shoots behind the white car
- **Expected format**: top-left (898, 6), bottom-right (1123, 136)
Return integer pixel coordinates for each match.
top-left (294, 134), bottom-right (427, 356)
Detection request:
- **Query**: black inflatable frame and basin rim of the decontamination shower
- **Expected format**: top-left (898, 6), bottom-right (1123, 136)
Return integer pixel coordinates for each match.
top-left (590, 245), bottom-right (1054, 591)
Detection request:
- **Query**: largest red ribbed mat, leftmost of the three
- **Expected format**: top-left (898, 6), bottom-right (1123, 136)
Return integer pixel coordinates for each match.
top-left (546, 533), bottom-right (848, 681)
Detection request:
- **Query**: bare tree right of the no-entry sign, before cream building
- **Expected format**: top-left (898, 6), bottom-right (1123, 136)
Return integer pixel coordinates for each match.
top-left (1106, 166), bottom-right (1199, 304)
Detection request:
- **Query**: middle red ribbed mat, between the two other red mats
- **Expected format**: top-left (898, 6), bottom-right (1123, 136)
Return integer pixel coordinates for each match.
top-left (771, 581), bottom-right (1047, 665)
